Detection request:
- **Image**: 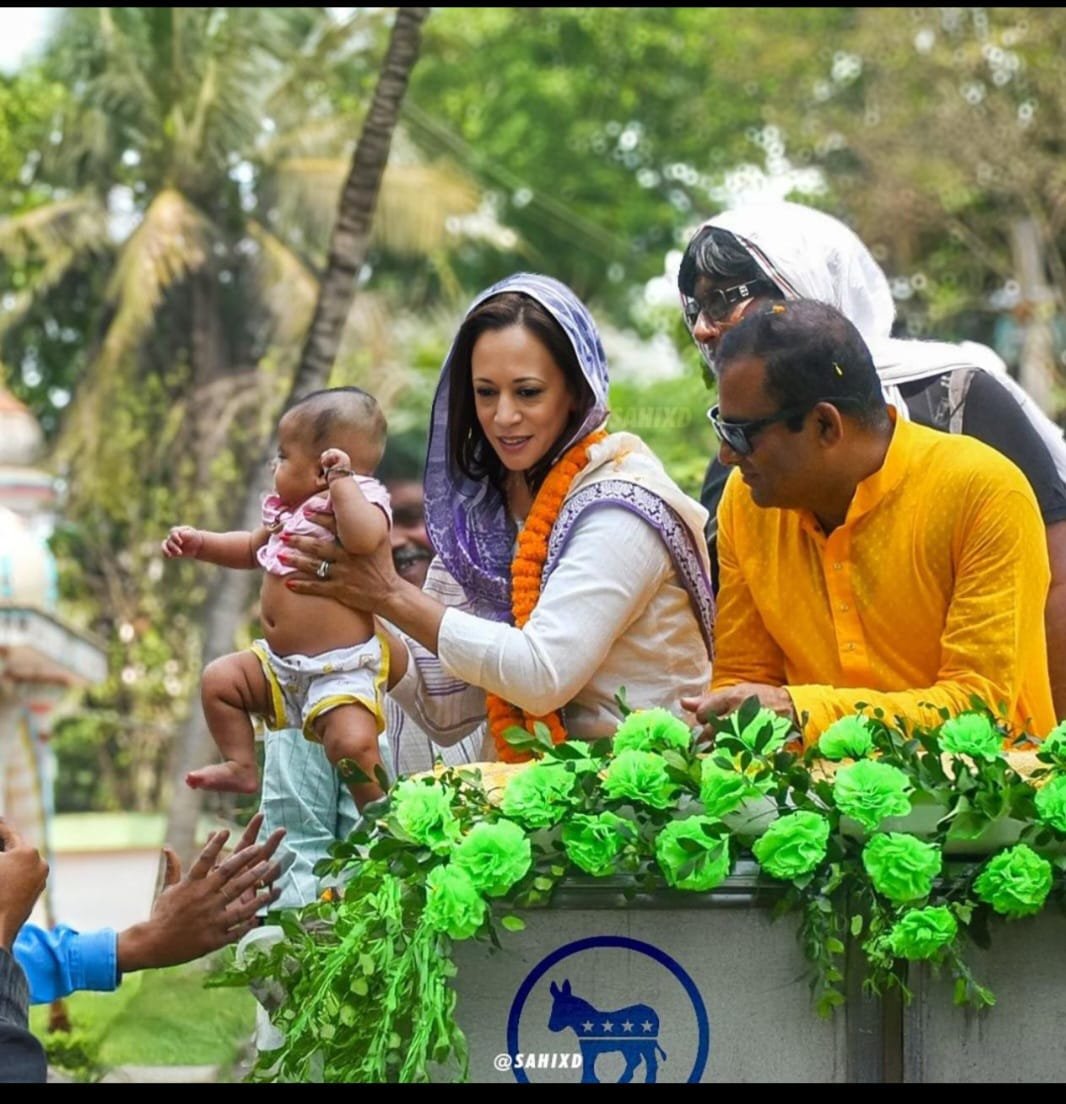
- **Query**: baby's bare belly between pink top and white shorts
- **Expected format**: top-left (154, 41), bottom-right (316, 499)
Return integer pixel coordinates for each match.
top-left (259, 573), bottom-right (374, 656)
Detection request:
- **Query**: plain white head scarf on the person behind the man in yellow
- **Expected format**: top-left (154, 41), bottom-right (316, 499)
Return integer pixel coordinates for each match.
top-left (701, 201), bottom-right (1066, 479)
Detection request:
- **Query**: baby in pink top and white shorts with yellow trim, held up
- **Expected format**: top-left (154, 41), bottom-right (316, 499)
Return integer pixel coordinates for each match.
top-left (162, 388), bottom-right (392, 808)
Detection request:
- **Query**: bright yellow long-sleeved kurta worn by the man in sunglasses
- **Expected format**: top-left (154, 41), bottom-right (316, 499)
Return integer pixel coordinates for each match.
top-left (712, 422), bottom-right (1055, 741)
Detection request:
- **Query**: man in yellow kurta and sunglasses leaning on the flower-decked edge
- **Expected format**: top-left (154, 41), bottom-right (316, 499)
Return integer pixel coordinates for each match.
top-left (683, 301), bottom-right (1055, 741)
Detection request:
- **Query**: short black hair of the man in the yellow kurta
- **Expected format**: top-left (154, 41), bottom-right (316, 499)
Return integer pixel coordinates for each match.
top-left (715, 299), bottom-right (889, 431)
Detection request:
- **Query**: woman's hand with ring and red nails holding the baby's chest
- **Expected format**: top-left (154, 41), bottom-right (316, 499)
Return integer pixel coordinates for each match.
top-left (281, 523), bottom-right (411, 618)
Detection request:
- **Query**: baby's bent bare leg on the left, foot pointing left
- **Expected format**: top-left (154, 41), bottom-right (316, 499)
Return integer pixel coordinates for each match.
top-left (185, 651), bottom-right (271, 794)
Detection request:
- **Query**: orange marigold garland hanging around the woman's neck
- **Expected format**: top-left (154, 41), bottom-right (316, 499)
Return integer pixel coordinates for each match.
top-left (486, 429), bottom-right (607, 763)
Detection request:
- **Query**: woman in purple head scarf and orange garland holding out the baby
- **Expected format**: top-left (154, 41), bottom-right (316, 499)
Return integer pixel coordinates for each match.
top-left (291, 273), bottom-right (714, 760)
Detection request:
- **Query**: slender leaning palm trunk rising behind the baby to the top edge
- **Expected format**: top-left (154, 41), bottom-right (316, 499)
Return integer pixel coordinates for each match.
top-left (167, 8), bottom-right (429, 863)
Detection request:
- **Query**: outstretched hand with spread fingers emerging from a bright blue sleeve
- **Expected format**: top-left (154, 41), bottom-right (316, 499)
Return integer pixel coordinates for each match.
top-left (118, 813), bottom-right (285, 973)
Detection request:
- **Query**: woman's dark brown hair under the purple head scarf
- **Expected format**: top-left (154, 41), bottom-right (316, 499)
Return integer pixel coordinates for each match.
top-left (446, 291), bottom-right (595, 493)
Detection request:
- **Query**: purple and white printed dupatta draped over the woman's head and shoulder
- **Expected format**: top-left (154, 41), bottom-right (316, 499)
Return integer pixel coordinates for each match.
top-left (425, 273), bottom-right (714, 654)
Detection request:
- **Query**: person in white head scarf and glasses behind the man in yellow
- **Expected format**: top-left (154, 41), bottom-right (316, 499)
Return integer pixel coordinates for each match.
top-left (678, 202), bottom-right (1066, 716)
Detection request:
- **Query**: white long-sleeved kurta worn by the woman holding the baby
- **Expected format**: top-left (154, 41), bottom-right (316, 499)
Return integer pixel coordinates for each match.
top-left (392, 505), bottom-right (711, 744)
